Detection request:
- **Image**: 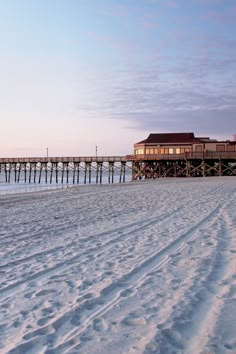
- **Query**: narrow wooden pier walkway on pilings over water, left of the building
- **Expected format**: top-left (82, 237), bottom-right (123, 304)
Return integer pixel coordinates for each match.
top-left (0, 156), bottom-right (129, 184)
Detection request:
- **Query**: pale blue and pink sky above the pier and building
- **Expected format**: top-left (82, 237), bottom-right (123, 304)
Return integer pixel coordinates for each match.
top-left (0, 0), bottom-right (236, 157)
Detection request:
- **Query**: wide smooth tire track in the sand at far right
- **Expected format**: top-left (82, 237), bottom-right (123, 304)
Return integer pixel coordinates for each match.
top-left (185, 210), bottom-right (236, 354)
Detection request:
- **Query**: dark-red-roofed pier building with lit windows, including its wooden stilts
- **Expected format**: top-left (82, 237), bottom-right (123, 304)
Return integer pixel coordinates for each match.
top-left (127, 132), bottom-right (236, 180)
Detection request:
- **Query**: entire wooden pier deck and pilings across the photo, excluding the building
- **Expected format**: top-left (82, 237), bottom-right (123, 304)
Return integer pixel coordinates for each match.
top-left (0, 152), bottom-right (236, 184)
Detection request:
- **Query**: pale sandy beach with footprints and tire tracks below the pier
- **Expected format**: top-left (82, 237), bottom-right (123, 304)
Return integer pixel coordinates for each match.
top-left (0, 177), bottom-right (236, 354)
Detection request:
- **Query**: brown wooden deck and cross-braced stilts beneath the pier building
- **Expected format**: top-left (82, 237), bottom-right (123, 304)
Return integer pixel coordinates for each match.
top-left (126, 152), bottom-right (236, 180)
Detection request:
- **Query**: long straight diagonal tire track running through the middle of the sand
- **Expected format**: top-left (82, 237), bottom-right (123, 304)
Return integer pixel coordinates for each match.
top-left (12, 205), bottom-right (221, 354)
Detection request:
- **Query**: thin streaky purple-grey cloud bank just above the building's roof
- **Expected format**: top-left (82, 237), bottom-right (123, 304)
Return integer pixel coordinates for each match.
top-left (77, 44), bottom-right (236, 138)
